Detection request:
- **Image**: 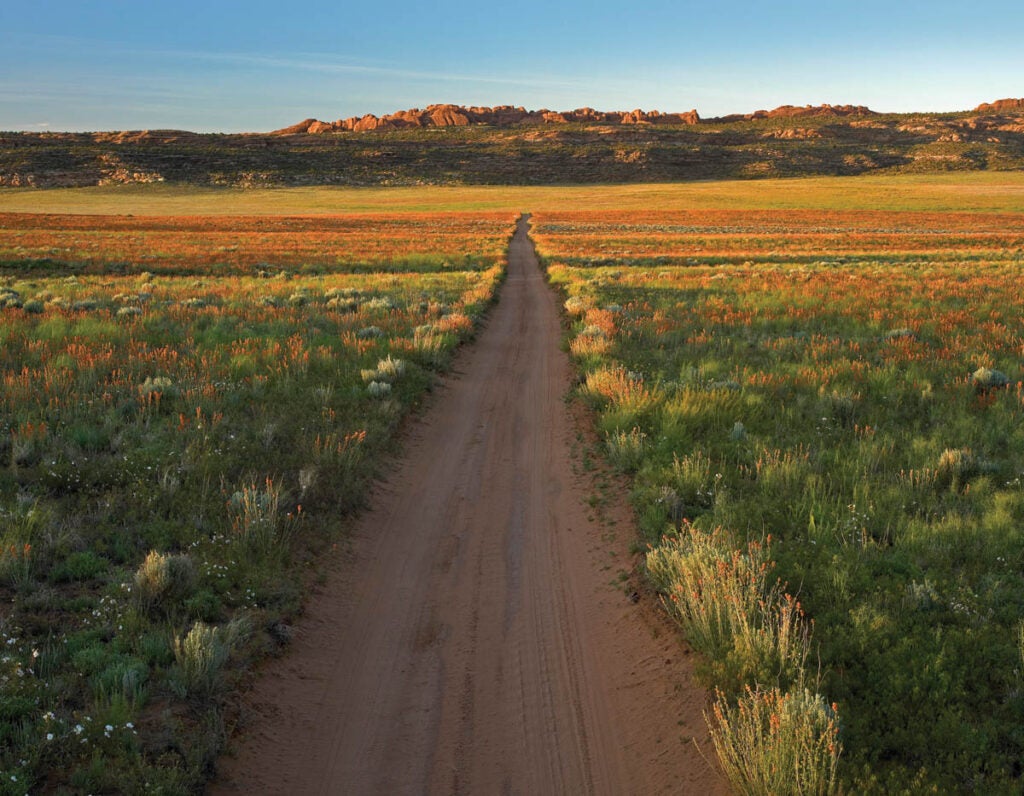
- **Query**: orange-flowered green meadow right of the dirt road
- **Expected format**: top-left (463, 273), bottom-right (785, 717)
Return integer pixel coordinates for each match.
top-left (534, 201), bottom-right (1024, 793)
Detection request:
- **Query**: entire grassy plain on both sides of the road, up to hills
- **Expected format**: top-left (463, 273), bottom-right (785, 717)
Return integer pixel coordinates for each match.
top-left (0, 177), bottom-right (1024, 793)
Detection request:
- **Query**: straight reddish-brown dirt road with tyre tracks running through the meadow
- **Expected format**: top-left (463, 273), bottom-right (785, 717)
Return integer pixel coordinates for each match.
top-left (212, 221), bottom-right (724, 795)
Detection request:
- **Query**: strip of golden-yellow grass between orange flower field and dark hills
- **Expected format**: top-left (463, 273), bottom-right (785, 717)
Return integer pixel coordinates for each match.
top-left (0, 171), bottom-right (1024, 215)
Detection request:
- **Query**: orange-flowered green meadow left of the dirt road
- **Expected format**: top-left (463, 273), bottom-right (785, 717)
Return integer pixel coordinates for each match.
top-left (0, 207), bottom-right (515, 794)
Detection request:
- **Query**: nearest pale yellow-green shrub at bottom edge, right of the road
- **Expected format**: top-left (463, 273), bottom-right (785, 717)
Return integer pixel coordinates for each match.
top-left (707, 687), bottom-right (843, 796)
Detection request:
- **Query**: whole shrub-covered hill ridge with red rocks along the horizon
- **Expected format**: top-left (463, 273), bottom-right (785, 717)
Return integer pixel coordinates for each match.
top-left (0, 100), bottom-right (1024, 187)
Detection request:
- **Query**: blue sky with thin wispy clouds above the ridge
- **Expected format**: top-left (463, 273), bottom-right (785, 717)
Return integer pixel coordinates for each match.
top-left (0, 0), bottom-right (1024, 132)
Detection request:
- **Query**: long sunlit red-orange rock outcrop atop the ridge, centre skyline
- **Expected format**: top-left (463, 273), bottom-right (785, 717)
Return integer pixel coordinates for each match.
top-left (271, 104), bottom-right (700, 135)
